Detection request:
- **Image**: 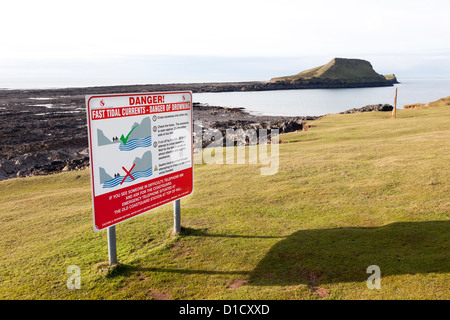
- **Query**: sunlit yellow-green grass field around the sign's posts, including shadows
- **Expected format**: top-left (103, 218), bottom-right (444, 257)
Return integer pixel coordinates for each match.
top-left (0, 100), bottom-right (450, 299)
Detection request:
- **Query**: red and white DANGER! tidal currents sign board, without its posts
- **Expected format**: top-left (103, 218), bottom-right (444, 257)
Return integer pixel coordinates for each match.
top-left (86, 91), bottom-right (193, 231)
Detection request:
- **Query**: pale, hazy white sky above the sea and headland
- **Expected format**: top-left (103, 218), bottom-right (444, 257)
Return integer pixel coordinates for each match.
top-left (0, 0), bottom-right (450, 88)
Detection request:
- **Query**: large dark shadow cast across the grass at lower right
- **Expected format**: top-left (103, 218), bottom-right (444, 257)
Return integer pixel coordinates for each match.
top-left (250, 221), bottom-right (450, 286)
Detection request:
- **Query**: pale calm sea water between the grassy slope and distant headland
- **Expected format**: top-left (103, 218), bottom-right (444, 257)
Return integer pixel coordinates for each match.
top-left (193, 79), bottom-right (450, 116)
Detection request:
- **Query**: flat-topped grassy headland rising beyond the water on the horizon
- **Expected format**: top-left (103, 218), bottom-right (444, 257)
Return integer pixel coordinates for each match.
top-left (270, 58), bottom-right (398, 87)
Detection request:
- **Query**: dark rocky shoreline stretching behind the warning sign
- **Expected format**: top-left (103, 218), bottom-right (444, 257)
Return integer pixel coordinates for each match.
top-left (0, 83), bottom-right (390, 180)
